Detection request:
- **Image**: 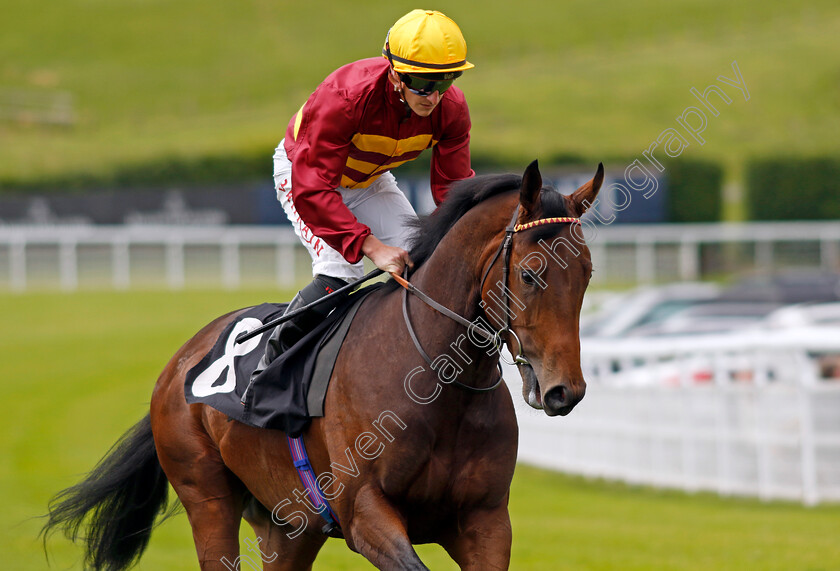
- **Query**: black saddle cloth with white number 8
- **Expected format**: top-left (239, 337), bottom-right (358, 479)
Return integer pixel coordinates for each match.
top-left (184, 284), bottom-right (381, 437)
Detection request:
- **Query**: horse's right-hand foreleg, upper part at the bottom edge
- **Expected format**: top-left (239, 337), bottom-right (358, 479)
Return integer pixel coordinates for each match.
top-left (441, 502), bottom-right (511, 571)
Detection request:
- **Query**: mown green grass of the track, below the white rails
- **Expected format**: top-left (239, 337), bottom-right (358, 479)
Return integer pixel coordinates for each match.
top-left (0, 290), bottom-right (840, 571)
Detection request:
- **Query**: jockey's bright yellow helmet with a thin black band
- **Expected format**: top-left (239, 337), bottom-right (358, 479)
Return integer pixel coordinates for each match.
top-left (382, 10), bottom-right (475, 75)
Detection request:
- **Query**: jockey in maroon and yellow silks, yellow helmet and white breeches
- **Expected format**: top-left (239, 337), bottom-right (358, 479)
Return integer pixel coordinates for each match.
top-left (252, 10), bottom-right (475, 378)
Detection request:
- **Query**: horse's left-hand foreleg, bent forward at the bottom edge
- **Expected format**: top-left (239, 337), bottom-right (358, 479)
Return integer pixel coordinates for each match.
top-left (342, 487), bottom-right (428, 571)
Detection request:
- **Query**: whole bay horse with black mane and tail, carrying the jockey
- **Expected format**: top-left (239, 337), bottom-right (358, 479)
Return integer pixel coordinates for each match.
top-left (44, 161), bottom-right (604, 571)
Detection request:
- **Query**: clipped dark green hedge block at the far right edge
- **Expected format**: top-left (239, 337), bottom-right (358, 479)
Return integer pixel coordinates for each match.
top-left (745, 157), bottom-right (840, 220)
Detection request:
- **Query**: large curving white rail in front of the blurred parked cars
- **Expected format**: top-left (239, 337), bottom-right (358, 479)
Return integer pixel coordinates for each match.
top-left (505, 329), bottom-right (840, 505)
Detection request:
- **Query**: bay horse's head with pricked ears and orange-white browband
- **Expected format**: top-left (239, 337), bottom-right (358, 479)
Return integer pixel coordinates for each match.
top-left (488, 161), bottom-right (604, 416)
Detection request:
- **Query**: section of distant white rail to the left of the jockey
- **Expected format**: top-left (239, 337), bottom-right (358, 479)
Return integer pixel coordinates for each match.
top-left (0, 225), bottom-right (302, 291)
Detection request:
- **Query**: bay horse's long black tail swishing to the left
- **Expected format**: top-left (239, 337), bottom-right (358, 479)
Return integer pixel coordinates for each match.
top-left (41, 415), bottom-right (174, 571)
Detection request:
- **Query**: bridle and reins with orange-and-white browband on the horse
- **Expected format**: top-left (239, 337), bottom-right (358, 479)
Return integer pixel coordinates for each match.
top-left (391, 204), bottom-right (580, 393)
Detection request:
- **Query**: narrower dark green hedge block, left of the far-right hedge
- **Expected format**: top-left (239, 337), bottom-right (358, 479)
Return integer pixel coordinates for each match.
top-left (665, 159), bottom-right (723, 222)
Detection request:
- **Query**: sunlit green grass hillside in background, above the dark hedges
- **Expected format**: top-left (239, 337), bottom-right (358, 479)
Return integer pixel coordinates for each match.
top-left (0, 0), bottom-right (840, 184)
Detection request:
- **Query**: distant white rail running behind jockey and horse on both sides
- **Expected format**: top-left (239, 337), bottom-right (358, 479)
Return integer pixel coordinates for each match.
top-left (0, 222), bottom-right (840, 291)
